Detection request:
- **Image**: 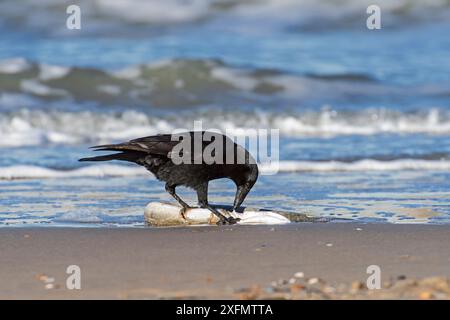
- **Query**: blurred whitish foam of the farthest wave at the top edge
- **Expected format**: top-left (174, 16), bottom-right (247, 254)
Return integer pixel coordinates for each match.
top-left (7, 0), bottom-right (448, 23)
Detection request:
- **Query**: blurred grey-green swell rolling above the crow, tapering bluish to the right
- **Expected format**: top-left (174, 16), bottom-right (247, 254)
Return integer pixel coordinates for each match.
top-left (0, 58), bottom-right (448, 110)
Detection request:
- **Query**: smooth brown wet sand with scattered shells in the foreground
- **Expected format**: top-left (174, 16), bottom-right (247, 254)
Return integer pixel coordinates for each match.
top-left (0, 223), bottom-right (450, 299)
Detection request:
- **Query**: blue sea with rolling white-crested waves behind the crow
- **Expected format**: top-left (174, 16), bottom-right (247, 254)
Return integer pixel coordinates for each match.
top-left (0, 0), bottom-right (450, 226)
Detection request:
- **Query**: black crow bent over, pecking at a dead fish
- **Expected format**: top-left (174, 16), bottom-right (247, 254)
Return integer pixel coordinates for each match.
top-left (79, 131), bottom-right (258, 224)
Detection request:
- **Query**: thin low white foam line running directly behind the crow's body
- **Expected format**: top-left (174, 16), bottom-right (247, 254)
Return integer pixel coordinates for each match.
top-left (0, 159), bottom-right (450, 180)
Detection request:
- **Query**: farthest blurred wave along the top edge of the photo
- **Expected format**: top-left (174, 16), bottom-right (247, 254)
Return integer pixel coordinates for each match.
top-left (0, 0), bottom-right (449, 36)
